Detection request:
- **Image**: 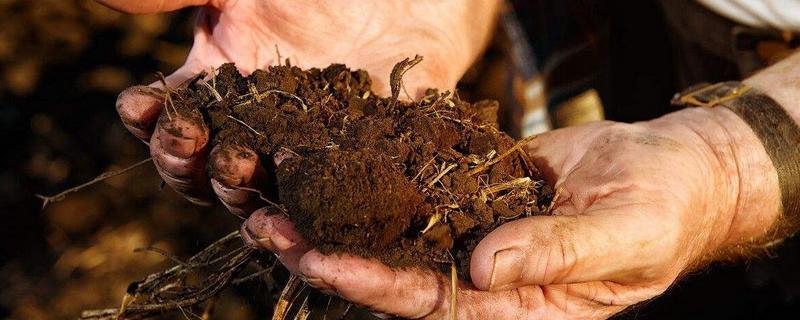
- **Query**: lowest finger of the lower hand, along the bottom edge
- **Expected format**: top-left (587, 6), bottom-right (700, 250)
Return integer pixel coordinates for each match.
top-left (299, 250), bottom-right (559, 320)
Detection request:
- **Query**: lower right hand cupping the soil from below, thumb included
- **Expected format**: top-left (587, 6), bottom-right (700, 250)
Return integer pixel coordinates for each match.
top-left (242, 108), bottom-right (780, 319)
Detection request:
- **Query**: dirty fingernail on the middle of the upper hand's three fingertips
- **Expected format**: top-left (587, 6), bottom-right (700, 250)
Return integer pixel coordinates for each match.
top-left (158, 118), bottom-right (208, 159)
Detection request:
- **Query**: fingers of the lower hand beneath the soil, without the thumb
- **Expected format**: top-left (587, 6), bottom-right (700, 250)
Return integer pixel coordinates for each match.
top-left (241, 209), bottom-right (640, 320)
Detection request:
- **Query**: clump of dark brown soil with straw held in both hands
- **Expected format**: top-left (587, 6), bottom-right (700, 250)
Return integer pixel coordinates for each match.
top-left (162, 59), bottom-right (552, 277)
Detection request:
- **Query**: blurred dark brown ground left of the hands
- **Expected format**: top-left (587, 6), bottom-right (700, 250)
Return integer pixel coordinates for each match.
top-left (0, 0), bottom-right (273, 319)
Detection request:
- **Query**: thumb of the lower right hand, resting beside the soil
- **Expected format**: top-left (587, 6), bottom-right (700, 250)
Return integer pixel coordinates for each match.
top-left (470, 203), bottom-right (681, 291)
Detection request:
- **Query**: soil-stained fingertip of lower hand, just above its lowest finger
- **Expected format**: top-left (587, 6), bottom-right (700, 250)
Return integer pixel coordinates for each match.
top-left (241, 209), bottom-right (311, 274)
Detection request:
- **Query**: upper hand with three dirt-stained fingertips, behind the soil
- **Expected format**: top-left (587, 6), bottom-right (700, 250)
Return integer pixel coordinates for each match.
top-left (98, 0), bottom-right (497, 213)
